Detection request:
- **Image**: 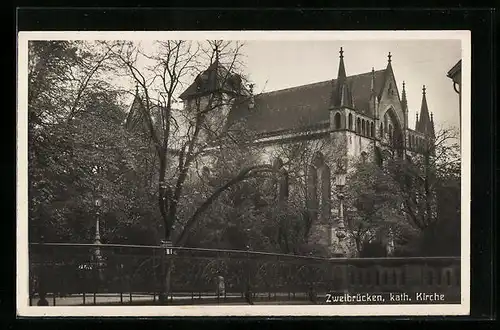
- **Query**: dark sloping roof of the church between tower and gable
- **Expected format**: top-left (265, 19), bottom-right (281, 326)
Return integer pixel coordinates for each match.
top-left (228, 69), bottom-right (386, 133)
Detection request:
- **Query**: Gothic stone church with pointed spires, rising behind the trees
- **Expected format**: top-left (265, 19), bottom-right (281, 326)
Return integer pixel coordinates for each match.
top-left (130, 48), bottom-right (434, 251)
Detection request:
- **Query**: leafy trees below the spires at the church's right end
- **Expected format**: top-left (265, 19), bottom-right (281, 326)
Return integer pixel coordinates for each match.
top-left (346, 129), bottom-right (460, 256)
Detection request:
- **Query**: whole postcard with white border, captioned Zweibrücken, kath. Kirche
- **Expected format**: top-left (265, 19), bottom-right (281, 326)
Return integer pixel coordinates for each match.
top-left (17, 31), bottom-right (470, 316)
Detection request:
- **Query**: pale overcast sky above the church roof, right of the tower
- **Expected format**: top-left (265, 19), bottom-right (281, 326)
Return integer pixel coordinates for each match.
top-left (238, 40), bottom-right (461, 129)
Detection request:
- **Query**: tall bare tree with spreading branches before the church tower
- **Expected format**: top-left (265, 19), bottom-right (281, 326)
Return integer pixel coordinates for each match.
top-left (107, 40), bottom-right (290, 302)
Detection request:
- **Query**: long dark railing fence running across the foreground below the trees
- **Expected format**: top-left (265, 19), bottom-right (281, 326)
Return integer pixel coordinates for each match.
top-left (29, 243), bottom-right (460, 305)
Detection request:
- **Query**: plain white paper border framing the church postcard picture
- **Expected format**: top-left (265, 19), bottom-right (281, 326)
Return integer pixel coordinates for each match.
top-left (16, 31), bottom-right (471, 317)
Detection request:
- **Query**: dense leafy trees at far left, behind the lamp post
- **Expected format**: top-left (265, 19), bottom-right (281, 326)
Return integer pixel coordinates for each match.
top-left (28, 41), bottom-right (161, 242)
